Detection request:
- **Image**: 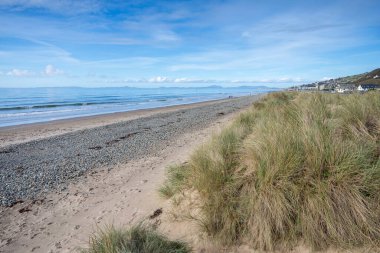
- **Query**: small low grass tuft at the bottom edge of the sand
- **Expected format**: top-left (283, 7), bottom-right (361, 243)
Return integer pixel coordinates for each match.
top-left (82, 225), bottom-right (190, 253)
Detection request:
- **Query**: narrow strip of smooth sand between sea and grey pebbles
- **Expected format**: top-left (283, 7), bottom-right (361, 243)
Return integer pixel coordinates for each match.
top-left (0, 93), bottom-right (267, 148)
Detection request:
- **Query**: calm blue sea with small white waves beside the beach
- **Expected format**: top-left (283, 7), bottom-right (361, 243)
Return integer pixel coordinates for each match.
top-left (0, 87), bottom-right (275, 127)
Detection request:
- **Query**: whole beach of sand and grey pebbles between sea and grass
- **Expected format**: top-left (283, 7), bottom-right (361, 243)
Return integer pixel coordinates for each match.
top-left (0, 96), bottom-right (259, 252)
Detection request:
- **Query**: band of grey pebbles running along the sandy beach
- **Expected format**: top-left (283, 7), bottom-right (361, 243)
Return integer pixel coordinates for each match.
top-left (0, 96), bottom-right (258, 206)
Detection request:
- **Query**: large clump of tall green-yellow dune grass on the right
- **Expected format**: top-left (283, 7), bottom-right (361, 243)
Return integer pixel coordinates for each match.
top-left (162, 92), bottom-right (380, 250)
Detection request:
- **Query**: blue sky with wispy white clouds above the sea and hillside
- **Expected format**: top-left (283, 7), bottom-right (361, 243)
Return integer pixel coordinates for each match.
top-left (0, 0), bottom-right (380, 87)
